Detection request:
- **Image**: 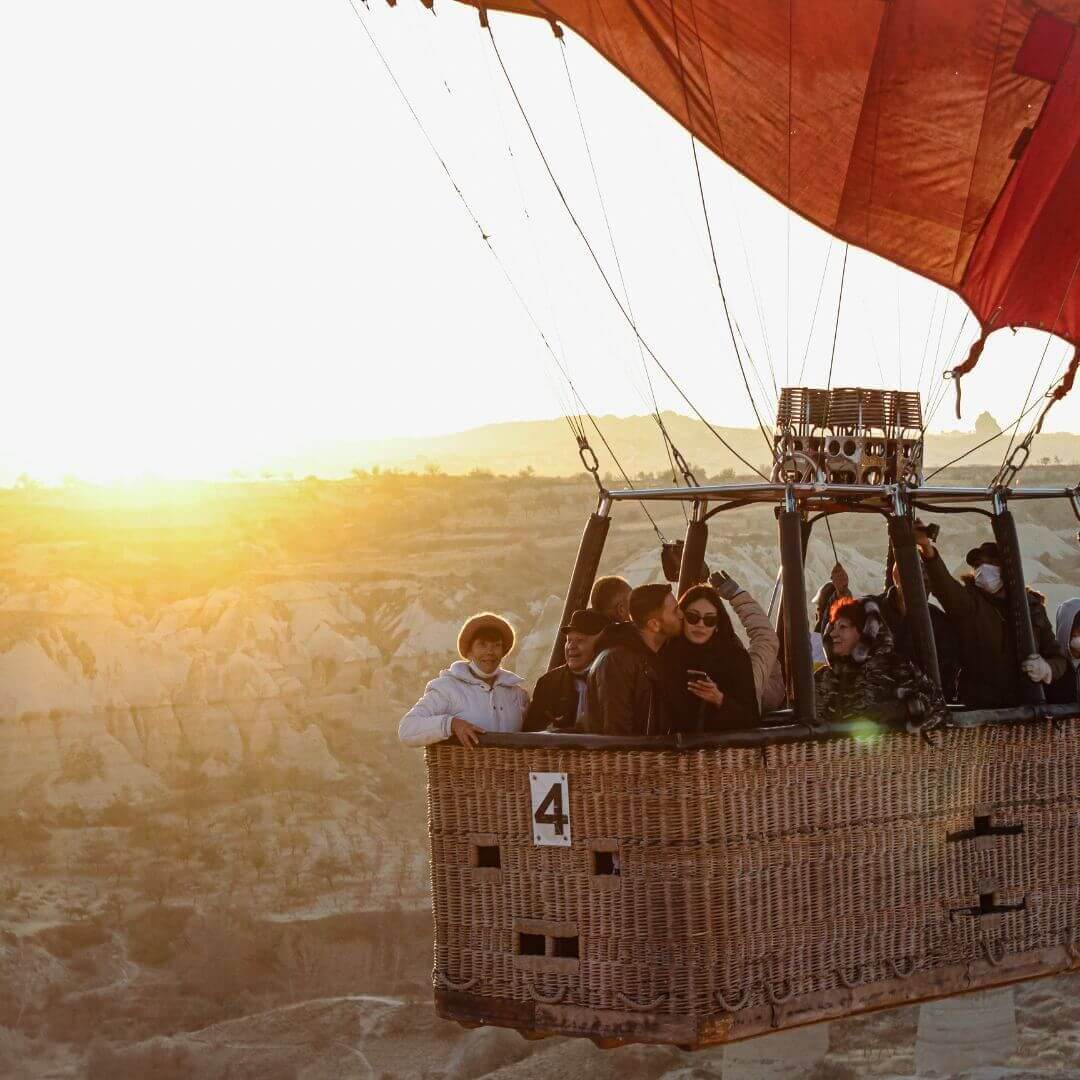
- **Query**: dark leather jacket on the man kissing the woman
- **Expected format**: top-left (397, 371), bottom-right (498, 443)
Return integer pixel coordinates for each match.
top-left (585, 622), bottom-right (675, 735)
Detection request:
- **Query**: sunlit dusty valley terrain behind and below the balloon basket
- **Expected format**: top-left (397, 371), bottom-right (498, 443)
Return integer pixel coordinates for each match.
top-left (0, 467), bottom-right (1080, 1080)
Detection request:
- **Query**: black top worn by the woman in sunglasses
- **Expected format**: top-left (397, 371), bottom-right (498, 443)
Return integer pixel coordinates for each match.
top-left (660, 624), bottom-right (760, 734)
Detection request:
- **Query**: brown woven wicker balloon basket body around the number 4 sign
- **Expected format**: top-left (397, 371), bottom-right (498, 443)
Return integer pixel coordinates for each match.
top-left (427, 719), bottom-right (1080, 1045)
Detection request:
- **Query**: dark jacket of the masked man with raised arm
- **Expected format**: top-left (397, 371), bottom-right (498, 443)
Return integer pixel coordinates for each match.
top-left (926, 553), bottom-right (1067, 708)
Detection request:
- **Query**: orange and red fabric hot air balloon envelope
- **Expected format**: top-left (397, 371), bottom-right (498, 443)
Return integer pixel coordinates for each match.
top-left (463, 0), bottom-right (1080, 401)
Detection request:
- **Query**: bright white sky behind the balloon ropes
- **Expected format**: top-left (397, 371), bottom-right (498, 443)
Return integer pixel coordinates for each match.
top-left (0, 0), bottom-right (1080, 482)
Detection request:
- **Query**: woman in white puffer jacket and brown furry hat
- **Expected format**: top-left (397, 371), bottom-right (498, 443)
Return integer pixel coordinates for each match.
top-left (397, 611), bottom-right (529, 750)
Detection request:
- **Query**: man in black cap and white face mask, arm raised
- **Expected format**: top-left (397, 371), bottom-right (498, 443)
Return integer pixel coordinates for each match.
top-left (915, 529), bottom-right (1066, 708)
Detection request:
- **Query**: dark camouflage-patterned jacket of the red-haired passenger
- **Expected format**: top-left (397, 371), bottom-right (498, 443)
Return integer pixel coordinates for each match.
top-left (815, 596), bottom-right (948, 731)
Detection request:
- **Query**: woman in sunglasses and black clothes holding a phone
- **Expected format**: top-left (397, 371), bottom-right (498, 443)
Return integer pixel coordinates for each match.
top-left (660, 585), bottom-right (759, 733)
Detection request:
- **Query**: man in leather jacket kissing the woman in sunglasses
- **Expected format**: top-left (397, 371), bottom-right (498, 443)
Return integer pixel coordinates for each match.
top-left (585, 584), bottom-right (683, 735)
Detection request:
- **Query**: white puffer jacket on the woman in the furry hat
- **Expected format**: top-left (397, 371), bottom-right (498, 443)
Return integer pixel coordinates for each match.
top-left (397, 660), bottom-right (529, 746)
